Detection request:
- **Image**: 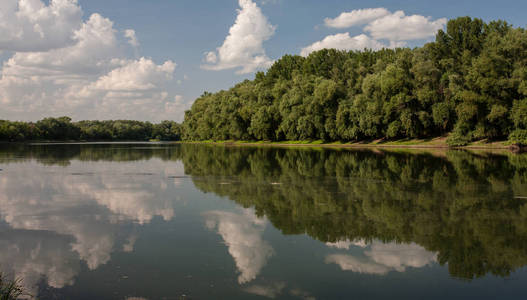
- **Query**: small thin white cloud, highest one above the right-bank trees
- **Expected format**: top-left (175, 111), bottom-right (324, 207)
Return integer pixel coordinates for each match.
top-left (324, 7), bottom-right (390, 28)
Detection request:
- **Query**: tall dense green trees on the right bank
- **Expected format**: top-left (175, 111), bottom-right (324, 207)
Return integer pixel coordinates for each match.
top-left (183, 17), bottom-right (527, 145)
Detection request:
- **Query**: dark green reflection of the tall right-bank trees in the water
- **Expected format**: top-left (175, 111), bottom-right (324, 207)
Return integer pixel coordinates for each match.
top-left (182, 145), bottom-right (527, 278)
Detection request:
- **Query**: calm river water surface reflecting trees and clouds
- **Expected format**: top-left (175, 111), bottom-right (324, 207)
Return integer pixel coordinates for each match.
top-left (0, 144), bottom-right (527, 300)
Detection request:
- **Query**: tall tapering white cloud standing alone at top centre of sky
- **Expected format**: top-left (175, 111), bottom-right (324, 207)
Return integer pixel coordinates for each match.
top-left (202, 0), bottom-right (275, 74)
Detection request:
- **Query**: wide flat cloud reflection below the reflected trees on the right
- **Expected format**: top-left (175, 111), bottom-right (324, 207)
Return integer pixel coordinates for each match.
top-left (326, 242), bottom-right (437, 275)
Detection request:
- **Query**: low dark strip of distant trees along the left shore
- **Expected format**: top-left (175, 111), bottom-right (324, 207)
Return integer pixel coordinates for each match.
top-left (0, 117), bottom-right (181, 142)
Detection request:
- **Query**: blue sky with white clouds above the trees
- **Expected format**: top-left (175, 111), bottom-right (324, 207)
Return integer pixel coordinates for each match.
top-left (0, 0), bottom-right (527, 122)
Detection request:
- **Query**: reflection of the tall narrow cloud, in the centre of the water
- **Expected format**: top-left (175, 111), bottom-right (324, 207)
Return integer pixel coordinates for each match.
top-left (205, 209), bottom-right (273, 284)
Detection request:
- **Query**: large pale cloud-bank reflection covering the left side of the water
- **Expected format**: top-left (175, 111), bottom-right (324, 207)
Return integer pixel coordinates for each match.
top-left (0, 159), bottom-right (181, 290)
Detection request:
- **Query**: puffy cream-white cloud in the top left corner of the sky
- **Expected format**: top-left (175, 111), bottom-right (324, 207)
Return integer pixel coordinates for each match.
top-left (0, 0), bottom-right (82, 51)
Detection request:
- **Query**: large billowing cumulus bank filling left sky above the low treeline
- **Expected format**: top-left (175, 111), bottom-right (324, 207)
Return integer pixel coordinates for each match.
top-left (0, 0), bottom-right (183, 121)
